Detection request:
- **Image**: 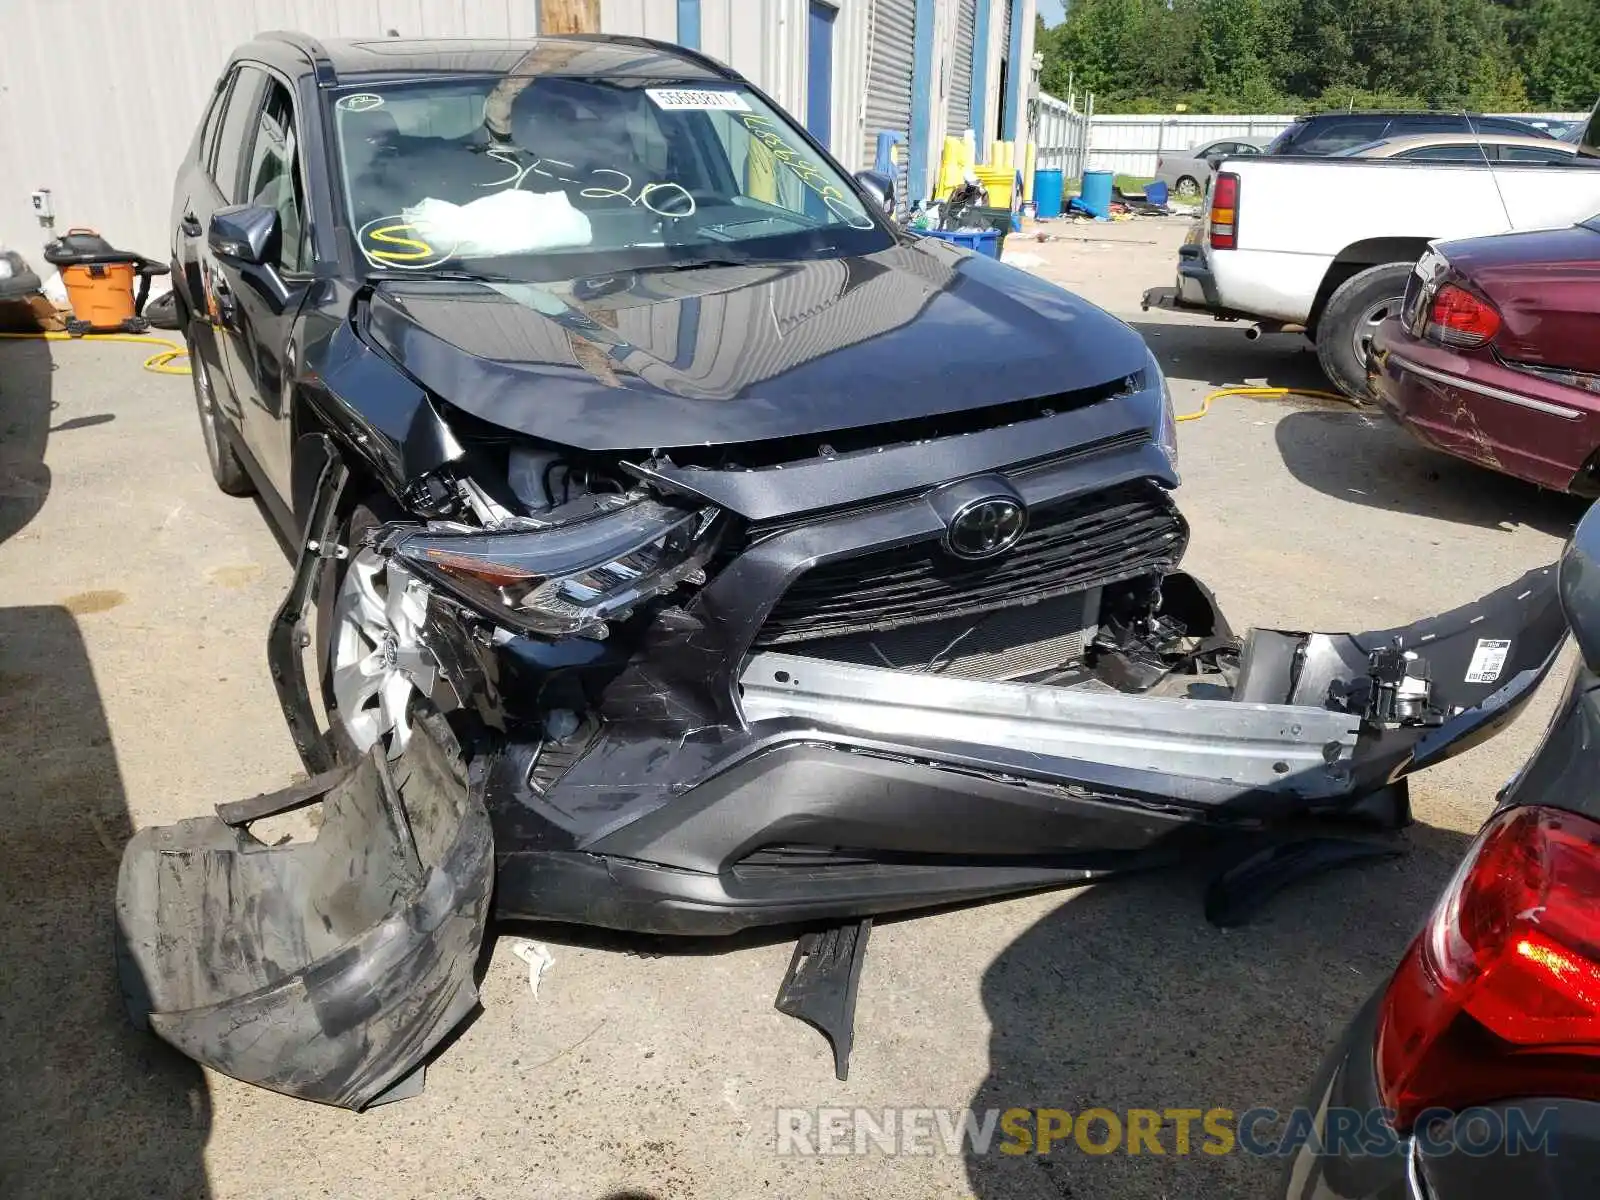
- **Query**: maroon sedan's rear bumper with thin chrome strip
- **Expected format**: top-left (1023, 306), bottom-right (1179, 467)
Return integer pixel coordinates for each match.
top-left (1368, 320), bottom-right (1600, 494)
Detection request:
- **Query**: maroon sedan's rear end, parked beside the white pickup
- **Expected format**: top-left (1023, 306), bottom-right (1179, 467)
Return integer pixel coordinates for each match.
top-left (1366, 216), bottom-right (1600, 496)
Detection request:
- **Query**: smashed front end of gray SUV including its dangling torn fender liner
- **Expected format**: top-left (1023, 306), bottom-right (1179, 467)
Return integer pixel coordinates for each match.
top-left (118, 336), bottom-right (1565, 1107)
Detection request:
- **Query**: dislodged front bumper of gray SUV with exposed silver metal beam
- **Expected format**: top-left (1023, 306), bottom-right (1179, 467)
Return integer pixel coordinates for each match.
top-left (486, 568), bottom-right (1565, 933)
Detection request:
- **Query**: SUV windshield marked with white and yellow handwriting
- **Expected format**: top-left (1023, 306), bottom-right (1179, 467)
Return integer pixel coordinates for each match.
top-left (334, 75), bottom-right (893, 280)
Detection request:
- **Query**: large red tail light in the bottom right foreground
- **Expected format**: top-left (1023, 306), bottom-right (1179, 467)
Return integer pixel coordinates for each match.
top-left (1378, 808), bottom-right (1600, 1130)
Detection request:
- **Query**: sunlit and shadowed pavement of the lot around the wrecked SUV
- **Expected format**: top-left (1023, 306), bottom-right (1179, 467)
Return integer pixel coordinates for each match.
top-left (0, 221), bottom-right (1581, 1200)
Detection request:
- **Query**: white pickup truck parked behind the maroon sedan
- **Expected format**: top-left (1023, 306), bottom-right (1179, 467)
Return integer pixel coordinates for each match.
top-left (1144, 115), bottom-right (1600, 397)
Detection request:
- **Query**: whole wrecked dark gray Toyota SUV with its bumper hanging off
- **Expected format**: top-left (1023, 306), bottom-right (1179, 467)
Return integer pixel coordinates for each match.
top-left (118, 34), bottom-right (1565, 1107)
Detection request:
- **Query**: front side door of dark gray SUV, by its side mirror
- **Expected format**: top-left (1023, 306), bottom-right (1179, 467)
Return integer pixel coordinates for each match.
top-left (218, 75), bottom-right (310, 502)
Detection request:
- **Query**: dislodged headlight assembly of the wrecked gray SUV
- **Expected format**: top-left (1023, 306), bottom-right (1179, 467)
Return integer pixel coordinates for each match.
top-left (390, 496), bottom-right (723, 638)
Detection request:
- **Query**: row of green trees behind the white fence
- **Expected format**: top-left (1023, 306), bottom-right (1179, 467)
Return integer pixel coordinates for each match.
top-left (1038, 0), bottom-right (1600, 112)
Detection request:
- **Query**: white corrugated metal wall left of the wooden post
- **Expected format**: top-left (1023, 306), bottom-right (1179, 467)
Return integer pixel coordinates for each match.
top-left (0, 0), bottom-right (539, 267)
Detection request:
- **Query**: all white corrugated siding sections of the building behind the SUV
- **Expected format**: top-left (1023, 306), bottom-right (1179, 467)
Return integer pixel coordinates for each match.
top-left (0, 0), bottom-right (1032, 266)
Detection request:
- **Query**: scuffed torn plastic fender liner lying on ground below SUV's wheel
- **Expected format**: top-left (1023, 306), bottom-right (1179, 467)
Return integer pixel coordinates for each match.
top-left (117, 714), bottom-right (494, 1109)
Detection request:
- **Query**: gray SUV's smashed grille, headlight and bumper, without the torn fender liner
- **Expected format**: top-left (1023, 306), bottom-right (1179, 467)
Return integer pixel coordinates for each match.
top-left (360, 356), bottom-right (1565, 934)
